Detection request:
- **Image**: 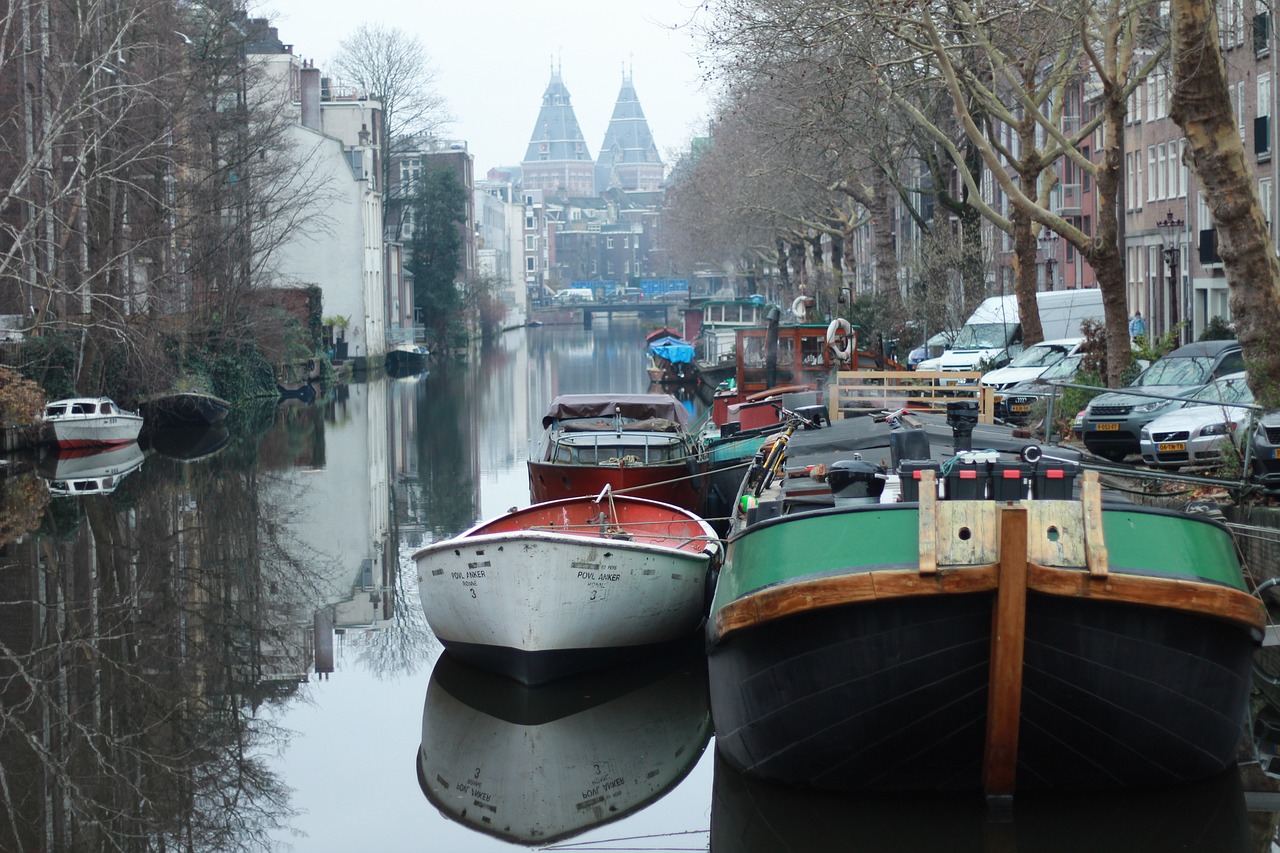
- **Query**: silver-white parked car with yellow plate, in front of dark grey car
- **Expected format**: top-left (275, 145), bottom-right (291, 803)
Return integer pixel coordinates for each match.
top-left (1139, 371), bottom-right (1253, 469)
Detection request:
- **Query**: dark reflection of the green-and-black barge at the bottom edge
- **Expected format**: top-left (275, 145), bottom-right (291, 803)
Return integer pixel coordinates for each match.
top-left (710, 753), bottom-right (1244, 853)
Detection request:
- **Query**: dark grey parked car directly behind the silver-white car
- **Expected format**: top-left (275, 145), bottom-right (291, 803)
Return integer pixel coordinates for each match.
top-left (1084, 341), bottom-right (1244, 462)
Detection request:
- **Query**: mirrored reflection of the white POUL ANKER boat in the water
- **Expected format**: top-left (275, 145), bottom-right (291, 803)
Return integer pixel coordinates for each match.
top-left (417, 647), bottom-right (712, 844)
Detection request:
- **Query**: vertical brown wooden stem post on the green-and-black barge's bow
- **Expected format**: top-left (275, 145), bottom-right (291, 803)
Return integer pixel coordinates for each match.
top-left (982, 505), bottom-right (1027, 802)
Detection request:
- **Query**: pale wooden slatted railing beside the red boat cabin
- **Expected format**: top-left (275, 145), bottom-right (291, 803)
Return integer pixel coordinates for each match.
top-left (827, 370), bottom-right (995, 424)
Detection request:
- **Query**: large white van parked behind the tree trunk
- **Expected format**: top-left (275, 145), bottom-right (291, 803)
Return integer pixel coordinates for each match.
top-left (916, 287), bottom-right (1102, 370)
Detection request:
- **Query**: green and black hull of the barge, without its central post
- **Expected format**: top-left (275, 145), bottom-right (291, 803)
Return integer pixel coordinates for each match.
top-left (708, 503), bottom-right (1261, 792)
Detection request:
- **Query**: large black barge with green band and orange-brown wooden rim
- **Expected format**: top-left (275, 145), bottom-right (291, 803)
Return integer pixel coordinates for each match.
top-left (707, 418), bottom-right (1266, 798)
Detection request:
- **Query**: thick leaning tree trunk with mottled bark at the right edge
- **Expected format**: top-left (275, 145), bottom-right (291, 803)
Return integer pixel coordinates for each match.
top-left (1170, 0), bottom-right (1280, 406)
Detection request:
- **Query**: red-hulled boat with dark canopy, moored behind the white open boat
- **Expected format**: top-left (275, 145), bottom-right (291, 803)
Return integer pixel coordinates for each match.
top-left (529, 394), bottom-right (707, 514)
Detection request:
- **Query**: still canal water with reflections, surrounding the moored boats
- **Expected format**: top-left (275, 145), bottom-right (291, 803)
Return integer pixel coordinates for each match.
top-left (0, 319), bottom-right (1280, 853)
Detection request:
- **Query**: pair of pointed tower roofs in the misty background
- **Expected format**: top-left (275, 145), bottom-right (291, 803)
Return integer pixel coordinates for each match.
top-left (521, 68), bottom-right (663, 199)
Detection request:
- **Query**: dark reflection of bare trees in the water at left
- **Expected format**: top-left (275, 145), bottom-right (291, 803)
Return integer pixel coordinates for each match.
top-left (0, 403), bottom-right (335, 850)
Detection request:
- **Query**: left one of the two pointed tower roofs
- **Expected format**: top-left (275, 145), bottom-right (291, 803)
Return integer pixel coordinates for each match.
top-left (520, 68), bottom-right (595, 199)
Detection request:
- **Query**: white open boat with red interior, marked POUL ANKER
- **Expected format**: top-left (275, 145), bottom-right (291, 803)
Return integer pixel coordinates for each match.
top-left (413, 489), bottom-right (719, 684)
